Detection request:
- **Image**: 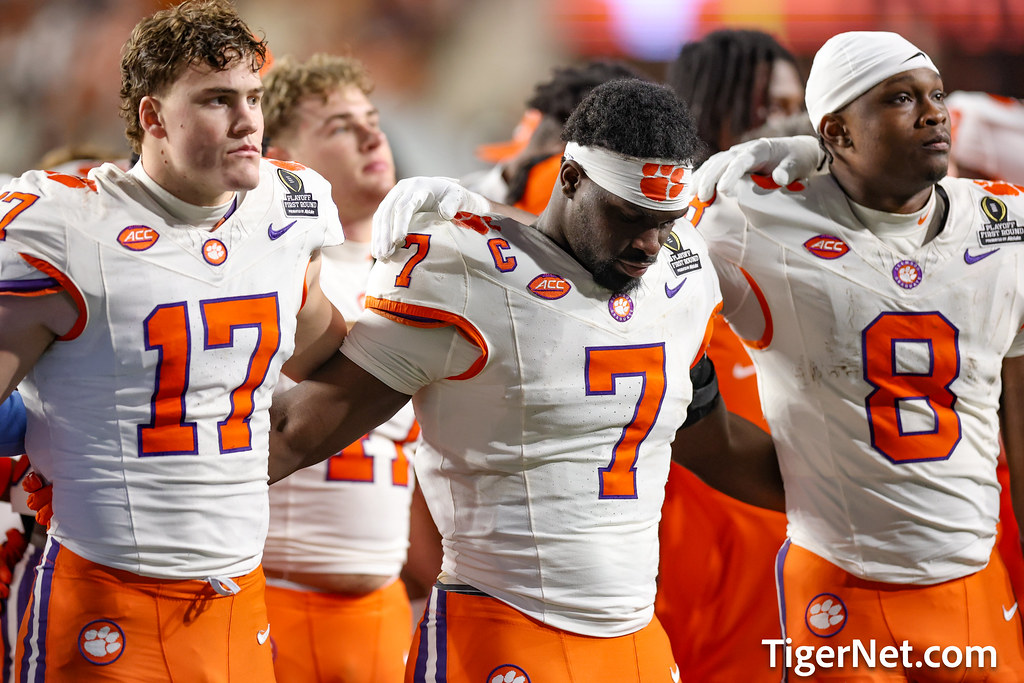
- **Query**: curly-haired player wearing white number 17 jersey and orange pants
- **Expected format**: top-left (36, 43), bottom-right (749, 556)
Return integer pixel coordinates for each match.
top-left (0, 0), bottom-right (345, 681)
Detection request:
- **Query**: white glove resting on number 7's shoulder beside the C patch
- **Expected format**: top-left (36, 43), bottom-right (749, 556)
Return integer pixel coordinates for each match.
top-left (370, 176), bottom-right (490, 261)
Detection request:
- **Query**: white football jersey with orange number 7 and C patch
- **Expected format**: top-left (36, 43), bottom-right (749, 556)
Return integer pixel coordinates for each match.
top-left (342, 209), bottom-right (720, 637)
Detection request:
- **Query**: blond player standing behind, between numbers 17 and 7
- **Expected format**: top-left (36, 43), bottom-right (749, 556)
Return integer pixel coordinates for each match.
top-left (263, 54), bottom-right (432, 683)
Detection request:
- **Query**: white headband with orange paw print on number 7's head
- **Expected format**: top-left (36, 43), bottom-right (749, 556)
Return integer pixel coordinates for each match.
top-left (565, 142), bottom-right (693, 211)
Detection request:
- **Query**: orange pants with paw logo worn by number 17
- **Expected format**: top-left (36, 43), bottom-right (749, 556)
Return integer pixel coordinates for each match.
top-left (14, 539), bottom-right (274, 683)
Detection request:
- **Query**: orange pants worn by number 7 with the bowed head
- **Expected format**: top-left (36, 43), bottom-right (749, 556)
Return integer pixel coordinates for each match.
top-left (406, 586), bottom-right (680, 683)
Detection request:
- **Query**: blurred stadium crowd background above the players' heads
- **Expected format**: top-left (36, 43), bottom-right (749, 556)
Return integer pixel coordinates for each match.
top-left (0, 0), bottom-right (1024, 177)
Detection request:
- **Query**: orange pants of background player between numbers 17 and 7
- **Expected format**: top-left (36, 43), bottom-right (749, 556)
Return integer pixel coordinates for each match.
top-left (266, 580), bottom-right (413, 683)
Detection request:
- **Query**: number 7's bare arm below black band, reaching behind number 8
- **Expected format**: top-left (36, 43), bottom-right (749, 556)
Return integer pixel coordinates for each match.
top-left (672, 400), bottom-right (785, 512)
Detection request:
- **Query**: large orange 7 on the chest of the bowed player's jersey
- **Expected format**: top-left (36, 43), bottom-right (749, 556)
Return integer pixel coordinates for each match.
top-left (586, 344), bottom-right (665, 498)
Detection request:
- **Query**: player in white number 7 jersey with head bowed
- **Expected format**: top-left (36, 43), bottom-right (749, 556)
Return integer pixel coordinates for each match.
top-left (271, 80), bottom-right (781, 683)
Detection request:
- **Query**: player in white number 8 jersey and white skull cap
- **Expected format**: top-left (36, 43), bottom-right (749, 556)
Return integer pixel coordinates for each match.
top-left (693, 33), bottom-right (1024, 681)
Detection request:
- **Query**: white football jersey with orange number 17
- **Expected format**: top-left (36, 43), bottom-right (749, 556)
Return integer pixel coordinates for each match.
top-left (0, 161), bottom-right (342, 579)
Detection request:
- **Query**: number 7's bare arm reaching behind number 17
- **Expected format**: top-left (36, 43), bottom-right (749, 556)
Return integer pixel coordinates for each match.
top-left (269, 352), bottom-right (410, 483)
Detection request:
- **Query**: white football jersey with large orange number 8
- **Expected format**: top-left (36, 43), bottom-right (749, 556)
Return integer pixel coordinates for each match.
top-left (696, 175), bottom-right (1024, 584)
